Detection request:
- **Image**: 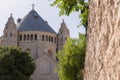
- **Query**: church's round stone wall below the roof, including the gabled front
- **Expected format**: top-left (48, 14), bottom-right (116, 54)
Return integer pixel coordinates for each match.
top-left (19, 31), bottom-right (58, 80)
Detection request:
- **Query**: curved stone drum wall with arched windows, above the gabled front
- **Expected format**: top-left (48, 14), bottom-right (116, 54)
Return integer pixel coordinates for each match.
top-left (19, 31), bottom-right (57, 59)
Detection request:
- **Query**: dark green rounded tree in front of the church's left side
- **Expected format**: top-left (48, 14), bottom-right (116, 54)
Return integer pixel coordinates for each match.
top-left (0, 47), bottom-right (35, 80)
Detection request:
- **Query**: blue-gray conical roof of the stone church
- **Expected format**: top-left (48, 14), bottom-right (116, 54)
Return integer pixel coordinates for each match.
top-left (18, 9), bottom-right (56, 34)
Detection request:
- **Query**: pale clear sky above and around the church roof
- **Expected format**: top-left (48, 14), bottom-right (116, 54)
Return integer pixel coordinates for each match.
top-left (0, 0), bottom-right (85, 38)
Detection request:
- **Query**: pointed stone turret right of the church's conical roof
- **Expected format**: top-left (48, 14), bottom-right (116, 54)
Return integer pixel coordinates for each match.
top-left (57, 19), bottom-right (70, 50)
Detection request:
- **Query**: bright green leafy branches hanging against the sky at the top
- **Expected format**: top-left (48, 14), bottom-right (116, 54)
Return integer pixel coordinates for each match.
top-left (51, 0), bottom-right (88, 28)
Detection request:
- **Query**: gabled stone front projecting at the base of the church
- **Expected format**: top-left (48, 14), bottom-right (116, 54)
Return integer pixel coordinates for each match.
top-left (31, 53), bottom-right (58, 80)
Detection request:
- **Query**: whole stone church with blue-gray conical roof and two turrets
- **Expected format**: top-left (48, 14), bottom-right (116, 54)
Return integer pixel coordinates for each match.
top-left (0, 8), bottom-right (70, 80)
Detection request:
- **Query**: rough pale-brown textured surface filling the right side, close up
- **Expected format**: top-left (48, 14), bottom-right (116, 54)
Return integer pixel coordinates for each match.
top-left (84, 0), bottom-right (120, 80)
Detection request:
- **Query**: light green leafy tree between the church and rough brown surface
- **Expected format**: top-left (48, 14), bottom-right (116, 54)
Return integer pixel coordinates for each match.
top-left (58, 35), bottom-right (86, 80)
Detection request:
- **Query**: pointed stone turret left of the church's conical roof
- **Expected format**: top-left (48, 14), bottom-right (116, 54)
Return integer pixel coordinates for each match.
top-left (3, 14), bottom-right (17, 46)
